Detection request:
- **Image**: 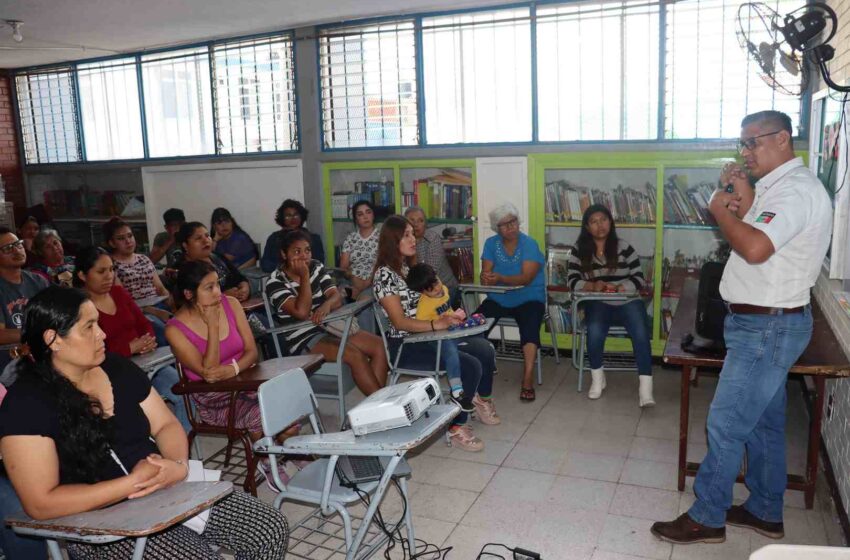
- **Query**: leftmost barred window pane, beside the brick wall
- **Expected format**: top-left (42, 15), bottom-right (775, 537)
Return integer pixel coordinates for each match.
top-left (15, 68), bottom-right (82, 165)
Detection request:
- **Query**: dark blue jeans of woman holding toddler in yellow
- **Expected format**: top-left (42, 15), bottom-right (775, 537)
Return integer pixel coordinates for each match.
top-left (390, 335), bottom-right (496, 426)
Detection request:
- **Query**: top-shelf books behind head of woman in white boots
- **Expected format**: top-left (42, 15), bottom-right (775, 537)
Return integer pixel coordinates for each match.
top-left (545, 179), bottom-right (655, 224)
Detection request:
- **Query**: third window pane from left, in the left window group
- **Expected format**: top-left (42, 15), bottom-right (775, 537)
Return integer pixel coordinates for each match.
top-left (142, 47), bottom-right (215, 157)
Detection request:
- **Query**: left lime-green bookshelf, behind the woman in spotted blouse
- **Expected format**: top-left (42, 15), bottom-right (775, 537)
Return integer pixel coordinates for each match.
top-left (322, 159), bottom-right (479, 282)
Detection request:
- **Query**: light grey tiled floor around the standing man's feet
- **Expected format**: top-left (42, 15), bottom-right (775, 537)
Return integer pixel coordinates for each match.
top-left (197, 358), bottom-right (843, 560)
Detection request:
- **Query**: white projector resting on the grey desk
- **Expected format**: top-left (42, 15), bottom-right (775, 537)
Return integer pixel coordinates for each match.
top-left (348, 377), bottom-right (440, 436)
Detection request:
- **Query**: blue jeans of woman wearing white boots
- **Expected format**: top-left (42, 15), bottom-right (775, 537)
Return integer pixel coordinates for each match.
top-left (582, 299), bottom-right (652, 375)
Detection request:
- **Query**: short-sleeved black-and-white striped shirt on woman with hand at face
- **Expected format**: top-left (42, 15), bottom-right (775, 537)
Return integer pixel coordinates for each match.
top-left (266, 260), bottom-right (336, 354)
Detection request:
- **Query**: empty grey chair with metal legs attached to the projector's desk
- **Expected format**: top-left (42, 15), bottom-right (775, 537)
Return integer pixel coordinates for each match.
top-left (254, 369), bottom-right (414, 558)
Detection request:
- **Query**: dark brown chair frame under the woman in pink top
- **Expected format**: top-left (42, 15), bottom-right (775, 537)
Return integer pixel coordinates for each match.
top-left (172, 362), bottom-right (257, 496)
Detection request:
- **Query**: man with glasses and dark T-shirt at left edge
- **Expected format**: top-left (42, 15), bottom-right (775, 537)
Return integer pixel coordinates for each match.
top-left (0, 226), bottom-right (48, 387)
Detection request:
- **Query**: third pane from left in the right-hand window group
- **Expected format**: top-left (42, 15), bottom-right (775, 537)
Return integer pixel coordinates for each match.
top-left (537, 0), bottom-right (659, 141)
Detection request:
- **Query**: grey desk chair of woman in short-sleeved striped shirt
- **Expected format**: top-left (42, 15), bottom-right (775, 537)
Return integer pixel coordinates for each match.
top-left (262, 278), bottom-right (362, 426)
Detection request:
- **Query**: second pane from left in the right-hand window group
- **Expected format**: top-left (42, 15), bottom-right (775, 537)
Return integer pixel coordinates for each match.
top-left (422, 7), bottom-right (532, 144)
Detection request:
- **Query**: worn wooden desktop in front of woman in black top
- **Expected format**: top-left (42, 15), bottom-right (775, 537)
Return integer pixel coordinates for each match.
top-left (6, 481), bottom-right (233, 560)
